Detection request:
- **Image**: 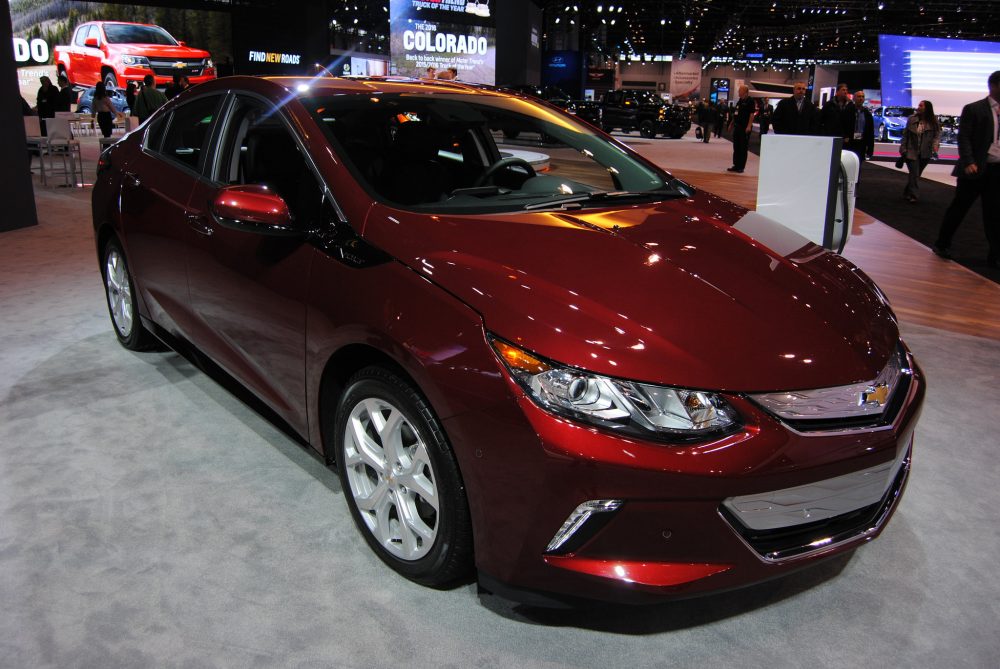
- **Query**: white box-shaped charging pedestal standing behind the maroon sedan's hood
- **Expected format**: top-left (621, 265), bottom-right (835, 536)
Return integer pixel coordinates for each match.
top-left (757, 135), bottom-right (861, 252)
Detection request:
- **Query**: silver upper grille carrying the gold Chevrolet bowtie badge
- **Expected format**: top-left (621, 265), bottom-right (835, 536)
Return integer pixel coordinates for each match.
top-left (749, 349), bottom-right (913, 422)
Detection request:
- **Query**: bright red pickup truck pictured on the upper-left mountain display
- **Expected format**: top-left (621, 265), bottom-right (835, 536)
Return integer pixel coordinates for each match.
top-left (54, 21), bottom-right (215, 88)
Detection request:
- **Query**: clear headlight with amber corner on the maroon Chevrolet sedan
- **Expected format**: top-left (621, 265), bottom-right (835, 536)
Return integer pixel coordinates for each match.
top-left (490, 338), bottom-right (741, 442)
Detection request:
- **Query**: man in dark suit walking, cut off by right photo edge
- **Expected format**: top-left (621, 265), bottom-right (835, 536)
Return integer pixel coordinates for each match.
top-left (934, 70), bottom-right (1000, 267)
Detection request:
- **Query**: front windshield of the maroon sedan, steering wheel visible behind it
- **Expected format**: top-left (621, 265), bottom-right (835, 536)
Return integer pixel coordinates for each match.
top-left (302, 91), bottom-right (691, 214)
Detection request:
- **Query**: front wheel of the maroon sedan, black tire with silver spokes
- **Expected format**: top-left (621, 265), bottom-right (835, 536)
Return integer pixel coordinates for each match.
top-left (334, 367), bottom-right (473, 587)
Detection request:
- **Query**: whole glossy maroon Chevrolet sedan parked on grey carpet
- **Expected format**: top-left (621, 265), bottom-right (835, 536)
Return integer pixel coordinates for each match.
top-left (93, 77), bottom-right (925, 602)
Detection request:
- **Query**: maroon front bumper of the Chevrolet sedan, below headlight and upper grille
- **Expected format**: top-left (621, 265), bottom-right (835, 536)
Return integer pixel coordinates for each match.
top-left (446, 358), bottom-right (924, 603)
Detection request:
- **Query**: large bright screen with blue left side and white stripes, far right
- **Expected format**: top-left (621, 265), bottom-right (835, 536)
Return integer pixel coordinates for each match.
top-left (878, 35), bottom-right (1000, 116)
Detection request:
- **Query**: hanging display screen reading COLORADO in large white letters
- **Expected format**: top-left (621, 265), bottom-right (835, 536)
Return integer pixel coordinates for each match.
top-left (389, 0), bottom-right (496, 85)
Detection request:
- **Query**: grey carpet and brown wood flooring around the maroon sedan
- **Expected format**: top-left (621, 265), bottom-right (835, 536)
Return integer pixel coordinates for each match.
top-left (0, 136), bottom-right (1000, 669)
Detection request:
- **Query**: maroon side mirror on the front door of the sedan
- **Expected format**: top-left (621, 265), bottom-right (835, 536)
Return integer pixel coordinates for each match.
top-left (211, 184), bottom-right (303, 237)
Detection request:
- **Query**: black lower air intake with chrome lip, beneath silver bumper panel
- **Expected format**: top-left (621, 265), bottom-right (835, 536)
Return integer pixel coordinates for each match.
top-left (719, 448), bottom-right (910, 562)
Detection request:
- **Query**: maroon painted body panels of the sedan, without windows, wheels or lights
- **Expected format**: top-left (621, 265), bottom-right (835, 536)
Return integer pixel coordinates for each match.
top-left (93, 77), bottom-right (925, 602)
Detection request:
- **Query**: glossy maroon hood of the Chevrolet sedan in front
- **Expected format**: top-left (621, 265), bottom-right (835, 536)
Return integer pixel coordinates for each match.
top-left (363, 193), bottom-right (898, 392)
